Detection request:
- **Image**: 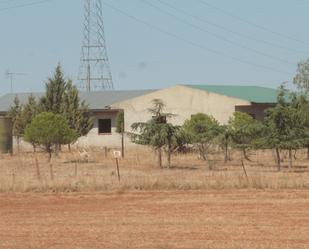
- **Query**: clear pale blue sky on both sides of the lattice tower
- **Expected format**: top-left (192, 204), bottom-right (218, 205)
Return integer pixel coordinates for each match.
top-left (0, 0), bottom-right (309, 95)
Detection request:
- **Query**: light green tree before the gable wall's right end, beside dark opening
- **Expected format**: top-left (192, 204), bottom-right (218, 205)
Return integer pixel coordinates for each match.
top-left (229, 112), bottom-right (261, 161)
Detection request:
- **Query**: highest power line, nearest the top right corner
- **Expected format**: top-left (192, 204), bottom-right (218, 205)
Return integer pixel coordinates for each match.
top-left (199, 0), bottom-right (309, 45)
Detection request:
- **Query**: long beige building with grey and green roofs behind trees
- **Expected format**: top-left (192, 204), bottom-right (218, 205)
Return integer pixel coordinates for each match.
top-left (0, 85), bottom-right (277, 147)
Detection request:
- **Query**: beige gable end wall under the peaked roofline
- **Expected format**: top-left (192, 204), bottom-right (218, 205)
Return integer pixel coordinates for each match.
top-left (112, 85), bottom-right (251, 131)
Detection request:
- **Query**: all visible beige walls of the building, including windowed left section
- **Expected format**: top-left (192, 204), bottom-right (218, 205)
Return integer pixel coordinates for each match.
top-left (15, 85), bottom-right (261, 150)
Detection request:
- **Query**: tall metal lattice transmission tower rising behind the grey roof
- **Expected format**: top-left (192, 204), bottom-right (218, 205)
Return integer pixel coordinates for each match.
top-left (78, 0), bottom-right (114, 92)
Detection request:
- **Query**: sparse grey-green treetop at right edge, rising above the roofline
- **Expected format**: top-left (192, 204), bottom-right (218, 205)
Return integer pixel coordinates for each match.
top-left (293, 59), bottom-right (309, 93)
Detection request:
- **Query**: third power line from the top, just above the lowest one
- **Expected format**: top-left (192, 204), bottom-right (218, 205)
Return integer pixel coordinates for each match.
top-left (141, 0), bottom-right (295, 65)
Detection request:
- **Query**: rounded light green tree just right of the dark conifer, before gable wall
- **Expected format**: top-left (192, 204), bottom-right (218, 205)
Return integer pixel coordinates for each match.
top-left (183, 113), bottom-right (220, 169)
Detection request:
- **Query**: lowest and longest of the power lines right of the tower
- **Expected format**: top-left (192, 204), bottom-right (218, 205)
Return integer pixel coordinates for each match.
top-left (103, 1), bottom-right (290, 74)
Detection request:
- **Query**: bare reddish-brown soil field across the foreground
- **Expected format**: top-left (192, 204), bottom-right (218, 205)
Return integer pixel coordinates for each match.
top-left (0, 191), bottom-right (309, 249)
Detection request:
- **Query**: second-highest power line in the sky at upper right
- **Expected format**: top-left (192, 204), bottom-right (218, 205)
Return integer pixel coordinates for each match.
top-left (157, 0), bottom-right (307, 54)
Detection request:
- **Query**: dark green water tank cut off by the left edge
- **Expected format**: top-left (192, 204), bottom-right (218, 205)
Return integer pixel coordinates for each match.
top-left (0, 117), bottom-right (13, 153)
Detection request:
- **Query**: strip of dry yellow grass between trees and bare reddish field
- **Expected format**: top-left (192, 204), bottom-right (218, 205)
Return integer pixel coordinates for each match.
top-left (0, 149), bottom-right (309, 193)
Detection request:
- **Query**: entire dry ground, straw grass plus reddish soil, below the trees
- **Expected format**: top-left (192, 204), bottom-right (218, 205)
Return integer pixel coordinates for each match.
top-left (0, 149), bottom-right (309, 249)
